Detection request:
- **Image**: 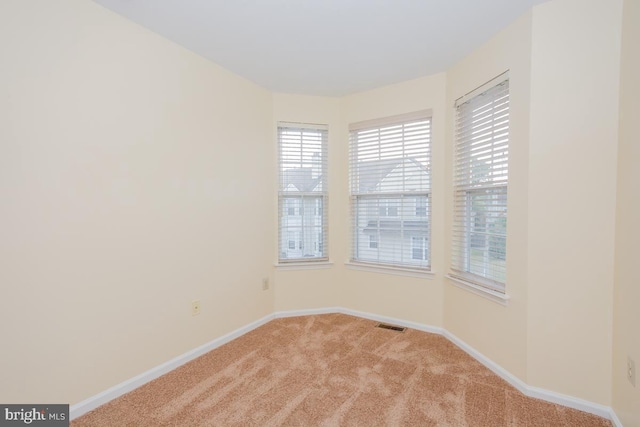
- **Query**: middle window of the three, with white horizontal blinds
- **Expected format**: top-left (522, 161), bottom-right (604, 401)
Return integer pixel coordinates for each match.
top-left (349, 111), bottom-right (431, 270)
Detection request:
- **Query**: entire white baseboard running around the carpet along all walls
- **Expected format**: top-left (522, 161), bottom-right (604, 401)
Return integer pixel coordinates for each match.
top-left (69, 307), bottom-right (623, 427)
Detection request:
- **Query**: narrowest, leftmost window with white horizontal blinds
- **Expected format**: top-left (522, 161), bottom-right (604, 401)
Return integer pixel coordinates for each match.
top-left (278, 123), bottom-right (328, 262)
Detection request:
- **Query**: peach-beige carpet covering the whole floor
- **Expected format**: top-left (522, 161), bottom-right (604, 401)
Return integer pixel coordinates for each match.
top-left (71, 314), bottom-right (611, 427)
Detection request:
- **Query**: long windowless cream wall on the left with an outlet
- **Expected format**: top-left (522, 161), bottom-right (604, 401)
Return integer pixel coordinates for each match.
top-left (0, 0), bottom-right (276, 404)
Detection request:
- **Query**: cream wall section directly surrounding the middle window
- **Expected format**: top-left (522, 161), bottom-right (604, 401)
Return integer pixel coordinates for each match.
top-left (337, 73), bottom-right (446, 326)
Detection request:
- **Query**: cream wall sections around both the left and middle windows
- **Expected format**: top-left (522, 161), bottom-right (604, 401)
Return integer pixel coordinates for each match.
top-left (274, 74), bottom-right (446, 326)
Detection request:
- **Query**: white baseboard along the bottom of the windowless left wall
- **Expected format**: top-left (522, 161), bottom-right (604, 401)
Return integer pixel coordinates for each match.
top-left (69, 314), bottom-right (275, 420)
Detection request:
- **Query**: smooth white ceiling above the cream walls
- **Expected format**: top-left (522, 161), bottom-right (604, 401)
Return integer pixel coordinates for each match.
top-left (94, 0), bottom-right (547, 96)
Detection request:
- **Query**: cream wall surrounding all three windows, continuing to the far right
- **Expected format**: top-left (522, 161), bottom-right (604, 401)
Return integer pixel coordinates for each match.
top-left (275, 0), bottom-right (638, 417)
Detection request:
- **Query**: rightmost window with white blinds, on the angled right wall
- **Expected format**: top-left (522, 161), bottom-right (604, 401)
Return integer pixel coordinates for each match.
top-left (451, 74), bottom-right (509, 293)
